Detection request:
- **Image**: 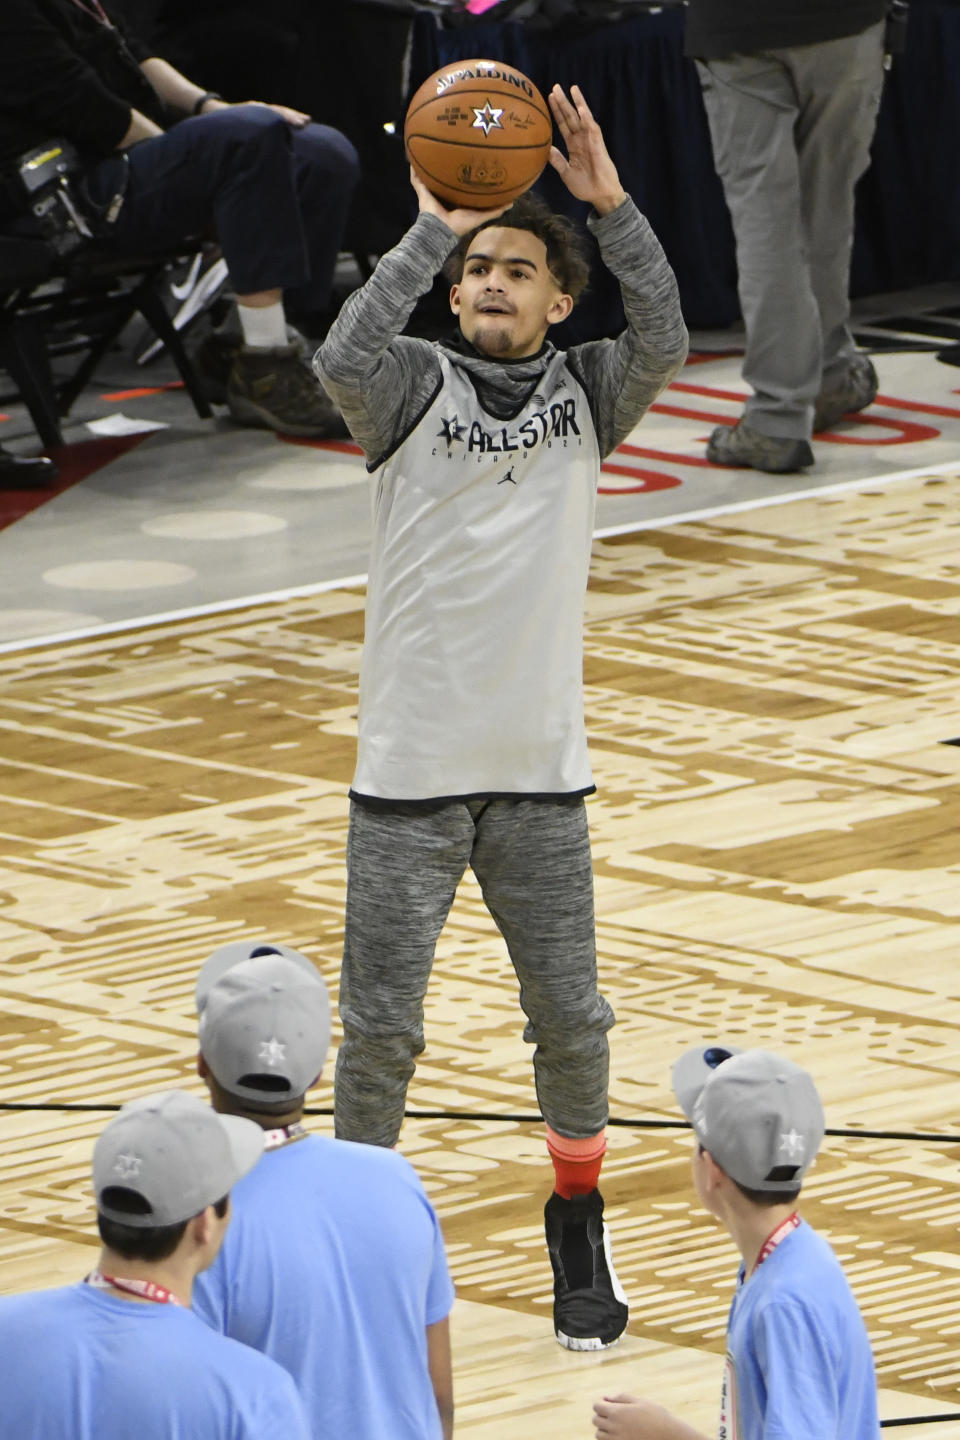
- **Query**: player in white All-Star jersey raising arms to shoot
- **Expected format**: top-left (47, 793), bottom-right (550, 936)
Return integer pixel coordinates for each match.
top-left (314, 86), bottom-right (687, 1349)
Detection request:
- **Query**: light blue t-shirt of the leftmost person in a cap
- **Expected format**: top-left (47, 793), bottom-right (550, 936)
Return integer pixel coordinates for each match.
top-left (0, 1284), bottom-right (309, 1440)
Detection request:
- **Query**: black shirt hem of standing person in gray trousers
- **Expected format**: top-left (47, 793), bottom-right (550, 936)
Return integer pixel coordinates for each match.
top-left (684, 0), bottom-right (887, 60)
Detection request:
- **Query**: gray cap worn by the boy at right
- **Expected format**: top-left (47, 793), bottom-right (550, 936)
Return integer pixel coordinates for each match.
top-left (672, 1044), bottom-right (825, 1192)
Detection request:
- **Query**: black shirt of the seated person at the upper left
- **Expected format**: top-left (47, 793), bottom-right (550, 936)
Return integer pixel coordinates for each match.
top-left (0, 0), bottom-right (170, 163)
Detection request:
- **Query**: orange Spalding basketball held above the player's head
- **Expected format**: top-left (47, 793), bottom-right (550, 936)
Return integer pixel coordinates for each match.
top-left (403, 60), bottom-right (553, 210)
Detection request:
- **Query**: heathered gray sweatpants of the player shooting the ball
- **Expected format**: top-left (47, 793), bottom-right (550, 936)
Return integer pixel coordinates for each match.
top-left (334, 799), bottom-right (613, 1145)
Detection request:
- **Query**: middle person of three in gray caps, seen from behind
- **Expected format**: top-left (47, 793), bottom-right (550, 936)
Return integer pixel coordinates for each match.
top-left (194, 942), bottom-right (453, 1440)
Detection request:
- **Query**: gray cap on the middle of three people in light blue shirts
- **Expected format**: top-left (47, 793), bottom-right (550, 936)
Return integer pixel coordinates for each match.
top-left (196, 940), bottom-right (330, 1107)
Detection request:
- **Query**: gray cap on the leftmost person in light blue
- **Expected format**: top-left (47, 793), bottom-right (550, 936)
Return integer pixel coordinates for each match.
top-left (94, 1090), bottom-right (263, 1228)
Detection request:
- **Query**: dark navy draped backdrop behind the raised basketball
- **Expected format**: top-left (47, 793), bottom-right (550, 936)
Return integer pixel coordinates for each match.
top-left (148, 0), bottom-right (960, 341)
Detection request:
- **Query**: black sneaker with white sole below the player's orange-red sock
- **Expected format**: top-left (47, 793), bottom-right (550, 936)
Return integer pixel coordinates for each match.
top-left (544, 1189), bottom-right (629, 1351)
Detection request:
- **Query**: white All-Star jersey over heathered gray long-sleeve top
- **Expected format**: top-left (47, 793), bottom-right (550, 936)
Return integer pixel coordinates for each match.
top-left (315, 202), bottom-right (687, 802)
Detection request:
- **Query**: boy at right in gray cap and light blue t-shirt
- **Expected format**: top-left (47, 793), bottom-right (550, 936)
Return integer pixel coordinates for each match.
top-left (593, 1045), bottom-right (879, 1440)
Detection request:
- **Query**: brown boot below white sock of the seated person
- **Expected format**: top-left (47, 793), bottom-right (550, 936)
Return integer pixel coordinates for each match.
top-left (226, 344), bottom-right (348, 439)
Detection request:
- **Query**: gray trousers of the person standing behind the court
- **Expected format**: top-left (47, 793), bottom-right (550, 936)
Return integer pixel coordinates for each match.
top-left (697, 22), bottom-right (884, 439)
